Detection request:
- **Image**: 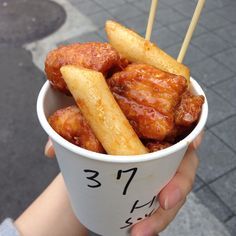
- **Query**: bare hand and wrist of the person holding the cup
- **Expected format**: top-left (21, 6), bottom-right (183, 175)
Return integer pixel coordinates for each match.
top-left (15, 133), bottom-right (203, 236)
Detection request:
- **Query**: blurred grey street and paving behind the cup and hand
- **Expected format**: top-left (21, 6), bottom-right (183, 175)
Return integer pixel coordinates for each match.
top-left (0, 0), bottom-right (236, 236)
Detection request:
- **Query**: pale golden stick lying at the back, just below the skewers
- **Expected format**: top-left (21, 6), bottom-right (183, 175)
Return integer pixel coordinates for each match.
top-left (106, 20), bottom-right (190, 83)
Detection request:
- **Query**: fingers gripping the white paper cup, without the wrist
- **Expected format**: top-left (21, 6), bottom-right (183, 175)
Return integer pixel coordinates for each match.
top-left (45, 133), bottom-right (203, 236)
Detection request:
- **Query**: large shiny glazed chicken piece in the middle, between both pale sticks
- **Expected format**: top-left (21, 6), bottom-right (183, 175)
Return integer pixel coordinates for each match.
top-left (107, 64), bottom-right (187, 141)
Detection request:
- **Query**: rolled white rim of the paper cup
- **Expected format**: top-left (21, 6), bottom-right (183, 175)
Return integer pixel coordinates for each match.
top-left (37, 78), bottom-right (208, 163)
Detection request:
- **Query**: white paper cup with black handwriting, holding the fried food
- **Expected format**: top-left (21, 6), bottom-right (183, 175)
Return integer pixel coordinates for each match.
top-left (37, 79), bottom-right (208, 236)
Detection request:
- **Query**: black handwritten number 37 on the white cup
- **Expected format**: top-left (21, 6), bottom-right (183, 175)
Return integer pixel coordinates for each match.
top-left (84, 168), bottom-right (137, 195)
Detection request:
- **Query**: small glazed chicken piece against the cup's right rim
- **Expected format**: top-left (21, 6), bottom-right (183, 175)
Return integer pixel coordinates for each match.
top-left (175, 91), bottom-right (204, 127)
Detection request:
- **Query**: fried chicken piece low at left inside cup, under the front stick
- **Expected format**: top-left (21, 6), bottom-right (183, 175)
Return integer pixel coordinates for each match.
top-left (48, 106), bottom-right (105, 153)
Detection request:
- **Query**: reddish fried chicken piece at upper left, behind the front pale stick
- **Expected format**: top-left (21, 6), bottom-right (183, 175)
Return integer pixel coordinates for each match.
top-left (45, 42), bottom-right (128, 94)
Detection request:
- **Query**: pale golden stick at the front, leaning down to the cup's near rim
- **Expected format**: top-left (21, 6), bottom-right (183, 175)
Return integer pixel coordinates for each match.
top-left (61, 65), bottom-right (147, 156)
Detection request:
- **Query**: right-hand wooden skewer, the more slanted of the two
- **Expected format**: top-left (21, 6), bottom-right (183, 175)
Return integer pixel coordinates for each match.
top-left (177, 0), bottom-right (205, 63)
